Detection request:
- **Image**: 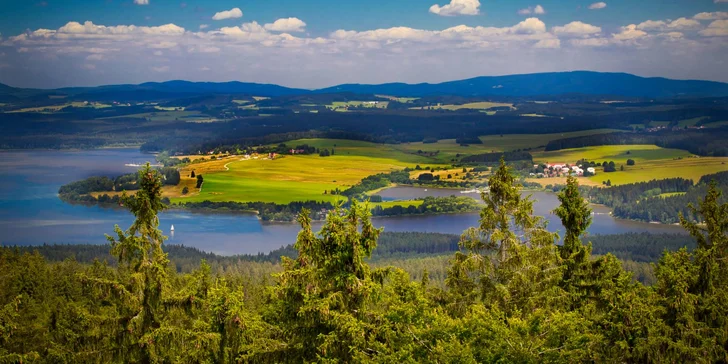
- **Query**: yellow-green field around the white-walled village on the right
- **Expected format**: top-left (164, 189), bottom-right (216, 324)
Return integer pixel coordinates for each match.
top-left (534, 145), bottom-right (728, 185)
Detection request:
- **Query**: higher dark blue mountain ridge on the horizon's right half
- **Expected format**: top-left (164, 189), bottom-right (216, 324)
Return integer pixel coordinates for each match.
top-left (315, 71), bottom-right (728, 98)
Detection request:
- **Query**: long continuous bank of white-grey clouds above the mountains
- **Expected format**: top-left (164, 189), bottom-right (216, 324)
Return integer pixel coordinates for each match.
top-left (0, 17), bottom-right (728, 87)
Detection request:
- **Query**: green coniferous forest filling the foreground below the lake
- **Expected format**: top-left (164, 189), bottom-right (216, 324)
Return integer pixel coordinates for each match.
top-left (0, 162), bottom-right (728, 363)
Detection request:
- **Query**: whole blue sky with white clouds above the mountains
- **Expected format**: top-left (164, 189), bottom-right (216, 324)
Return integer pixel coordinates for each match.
top-left (0, 0), bottom-right (728, 88)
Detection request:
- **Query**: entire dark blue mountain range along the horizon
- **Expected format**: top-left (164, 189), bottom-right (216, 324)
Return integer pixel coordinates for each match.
top-left (0, 71), bottom-right (728, 100)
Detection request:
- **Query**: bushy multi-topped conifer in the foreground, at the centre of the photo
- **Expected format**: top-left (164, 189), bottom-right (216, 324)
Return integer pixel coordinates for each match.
top-left (270, 200), bottom-right (386, 362)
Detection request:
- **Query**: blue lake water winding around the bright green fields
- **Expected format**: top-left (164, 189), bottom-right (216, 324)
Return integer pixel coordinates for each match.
top-left (0, 149), bottom-right (684, 255)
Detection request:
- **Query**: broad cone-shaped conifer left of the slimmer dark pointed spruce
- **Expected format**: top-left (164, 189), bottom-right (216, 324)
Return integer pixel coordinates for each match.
top-left (446, 158), bottom-right (560, 313)
